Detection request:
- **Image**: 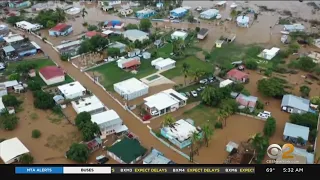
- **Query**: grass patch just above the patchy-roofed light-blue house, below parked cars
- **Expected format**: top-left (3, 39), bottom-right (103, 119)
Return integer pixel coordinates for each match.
top-left (182, 104), bottom-right (217, 126)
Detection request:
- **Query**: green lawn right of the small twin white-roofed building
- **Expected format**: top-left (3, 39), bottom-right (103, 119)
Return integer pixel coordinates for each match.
top-left (161, 56), bottom-right (213, 79)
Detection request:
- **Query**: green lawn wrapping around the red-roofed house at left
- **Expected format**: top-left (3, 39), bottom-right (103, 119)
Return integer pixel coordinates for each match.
top-left (5, 59), bottom-right (73, 86)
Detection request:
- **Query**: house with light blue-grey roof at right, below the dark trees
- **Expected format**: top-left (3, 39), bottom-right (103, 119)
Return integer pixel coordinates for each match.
top-left (281, 94), bottom-right (316, 114)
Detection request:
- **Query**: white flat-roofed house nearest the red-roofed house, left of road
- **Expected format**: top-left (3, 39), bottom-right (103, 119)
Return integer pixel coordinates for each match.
top-left (58, 81), bottom-right (86, 99)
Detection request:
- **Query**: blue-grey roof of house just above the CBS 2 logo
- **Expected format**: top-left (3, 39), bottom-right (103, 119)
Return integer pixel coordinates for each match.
top-left (283, 122), bottom-right (310, 140)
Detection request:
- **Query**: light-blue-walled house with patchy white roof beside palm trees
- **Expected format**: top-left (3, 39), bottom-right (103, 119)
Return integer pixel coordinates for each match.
top-left (160, 119), bottom-right (202, 149)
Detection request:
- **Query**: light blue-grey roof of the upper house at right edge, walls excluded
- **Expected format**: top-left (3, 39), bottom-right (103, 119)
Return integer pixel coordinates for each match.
top-left (281, 94), bottom-right (310, 111)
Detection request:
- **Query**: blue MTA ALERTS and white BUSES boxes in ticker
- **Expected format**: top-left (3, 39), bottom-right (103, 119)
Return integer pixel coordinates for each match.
top-left (15, 167), bottom-right (111, 174)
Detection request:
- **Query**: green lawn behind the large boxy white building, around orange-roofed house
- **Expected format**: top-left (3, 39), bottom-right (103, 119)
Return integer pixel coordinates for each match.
top-left (90, 60), bottom-right (157, 90)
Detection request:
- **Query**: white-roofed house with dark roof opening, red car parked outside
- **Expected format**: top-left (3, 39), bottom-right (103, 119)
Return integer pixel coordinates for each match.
top-left (143, 89), bottom-right (188, 116)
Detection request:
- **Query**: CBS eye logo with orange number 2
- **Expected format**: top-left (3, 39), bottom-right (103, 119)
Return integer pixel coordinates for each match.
top-left (267, 144), bottom-right (294, 159)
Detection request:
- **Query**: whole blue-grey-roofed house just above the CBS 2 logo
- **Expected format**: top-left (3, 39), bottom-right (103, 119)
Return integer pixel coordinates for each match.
top-left (283, 122), bottom-right (310, 146)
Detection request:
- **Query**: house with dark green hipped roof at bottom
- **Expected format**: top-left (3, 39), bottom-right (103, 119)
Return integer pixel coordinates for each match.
top-left (107, 137), bottom-right (147, 164)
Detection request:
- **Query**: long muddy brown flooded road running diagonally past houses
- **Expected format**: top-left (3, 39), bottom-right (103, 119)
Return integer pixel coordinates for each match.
top-left (6, 26), bottom-right (190, 164)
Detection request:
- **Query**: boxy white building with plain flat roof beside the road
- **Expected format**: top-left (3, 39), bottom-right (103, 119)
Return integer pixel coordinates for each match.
top-left (113, 78), bottom-right (149, 100)
